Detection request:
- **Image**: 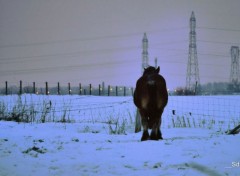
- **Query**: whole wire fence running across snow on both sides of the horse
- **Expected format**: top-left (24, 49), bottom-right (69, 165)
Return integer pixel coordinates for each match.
top-left (0, 94), bottom-right (240, 131)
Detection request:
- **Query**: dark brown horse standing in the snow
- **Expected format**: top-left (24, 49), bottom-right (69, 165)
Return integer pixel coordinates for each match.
top-left (134, 66), bottom-right (168, 141)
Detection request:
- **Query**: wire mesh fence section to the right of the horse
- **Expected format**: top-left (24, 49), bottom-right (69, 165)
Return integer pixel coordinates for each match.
top-left (163, 95), bottom-right (240, 131)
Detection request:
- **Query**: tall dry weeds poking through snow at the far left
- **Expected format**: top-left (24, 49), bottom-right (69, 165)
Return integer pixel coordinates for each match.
top-left (0, 95), bottom-right (73, 123)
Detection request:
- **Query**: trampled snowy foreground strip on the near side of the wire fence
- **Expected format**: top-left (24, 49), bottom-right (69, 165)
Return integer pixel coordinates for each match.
top-left (0, 121), bottom-right (240, 176)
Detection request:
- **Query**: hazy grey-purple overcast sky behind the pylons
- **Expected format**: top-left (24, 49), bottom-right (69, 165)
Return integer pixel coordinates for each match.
top-left (0, 0), bottom-right (240, 89)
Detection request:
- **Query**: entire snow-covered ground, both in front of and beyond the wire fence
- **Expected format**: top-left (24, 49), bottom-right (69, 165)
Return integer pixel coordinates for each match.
top-left (0, 95), bottom-right (240, 176)
